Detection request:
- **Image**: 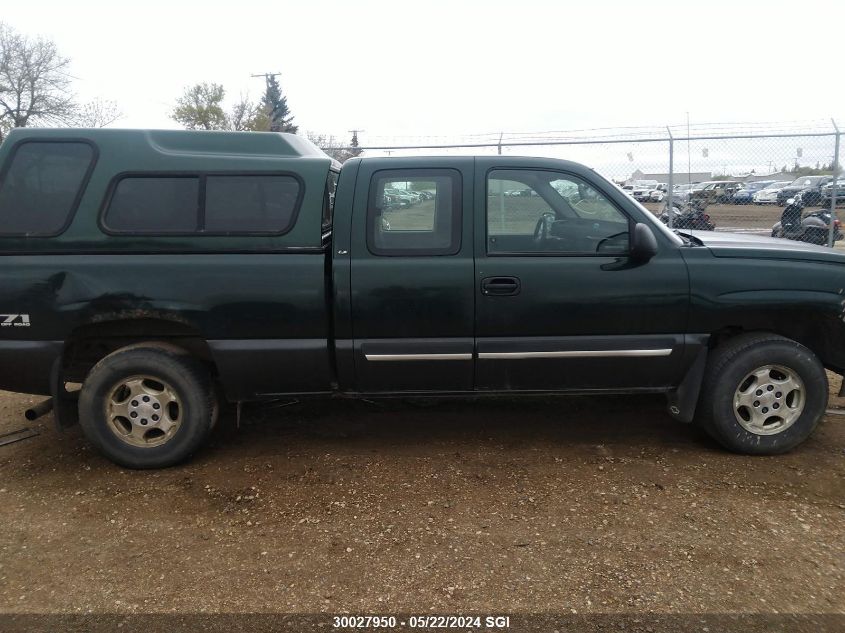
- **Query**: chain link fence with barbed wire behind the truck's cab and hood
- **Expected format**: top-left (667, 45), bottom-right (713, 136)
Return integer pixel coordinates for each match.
top-left (332, 119), bottom-right (845, 246)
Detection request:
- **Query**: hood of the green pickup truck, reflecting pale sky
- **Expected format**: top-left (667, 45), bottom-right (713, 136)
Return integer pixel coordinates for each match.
top-left (682, 231), bottom-right (845, 264)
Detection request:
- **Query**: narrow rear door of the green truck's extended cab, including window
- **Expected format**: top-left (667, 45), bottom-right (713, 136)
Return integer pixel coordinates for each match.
top-left (350, 158), bottom-right (475, 392)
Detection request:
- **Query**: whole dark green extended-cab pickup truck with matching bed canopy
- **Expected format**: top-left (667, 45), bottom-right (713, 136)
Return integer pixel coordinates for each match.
top-left (0, 129), bottom-right (845, 468)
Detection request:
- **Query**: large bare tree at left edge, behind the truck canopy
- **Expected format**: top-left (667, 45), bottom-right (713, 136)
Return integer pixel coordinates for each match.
top-left (0, 23), bottom-right (76, 135)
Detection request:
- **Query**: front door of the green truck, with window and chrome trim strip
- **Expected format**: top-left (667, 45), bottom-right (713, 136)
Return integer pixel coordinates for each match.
top-left (475, 159), bottom-right (688, 390)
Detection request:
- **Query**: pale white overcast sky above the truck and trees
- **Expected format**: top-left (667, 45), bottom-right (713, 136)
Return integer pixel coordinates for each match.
top-left (0, 0), bottom-right (845, 143)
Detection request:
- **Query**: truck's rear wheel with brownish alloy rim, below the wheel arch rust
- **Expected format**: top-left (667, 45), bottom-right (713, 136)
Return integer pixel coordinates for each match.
top-left (79, 343), bottom-right (217, 469)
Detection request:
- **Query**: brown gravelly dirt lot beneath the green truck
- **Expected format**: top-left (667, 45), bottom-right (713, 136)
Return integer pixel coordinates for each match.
top-left (0, 378), bottom-right (845, 614)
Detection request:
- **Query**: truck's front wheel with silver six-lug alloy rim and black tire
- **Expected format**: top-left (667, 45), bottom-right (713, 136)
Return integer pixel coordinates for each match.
top-left (696, 334), bottom-right (828, 455)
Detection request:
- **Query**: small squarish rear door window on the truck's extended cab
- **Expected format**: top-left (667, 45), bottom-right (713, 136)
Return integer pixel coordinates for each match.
top-left (367, 169), bottom-right (461, 255)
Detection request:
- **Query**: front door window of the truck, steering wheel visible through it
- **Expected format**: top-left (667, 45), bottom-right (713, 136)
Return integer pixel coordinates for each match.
top-left (487, 169), bottom-right (628, 254)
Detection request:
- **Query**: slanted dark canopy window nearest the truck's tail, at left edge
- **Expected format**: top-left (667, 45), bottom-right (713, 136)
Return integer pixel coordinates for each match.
top-left (0, 142), bottom-right (94, 235)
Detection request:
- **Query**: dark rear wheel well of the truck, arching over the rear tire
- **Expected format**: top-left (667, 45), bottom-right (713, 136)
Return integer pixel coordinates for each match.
top-left (62, 319), bottom-right (217, 383)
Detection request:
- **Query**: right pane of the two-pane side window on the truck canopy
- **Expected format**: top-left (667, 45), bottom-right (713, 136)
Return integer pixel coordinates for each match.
top-left (205, 176), bottom-right (299, 233)
